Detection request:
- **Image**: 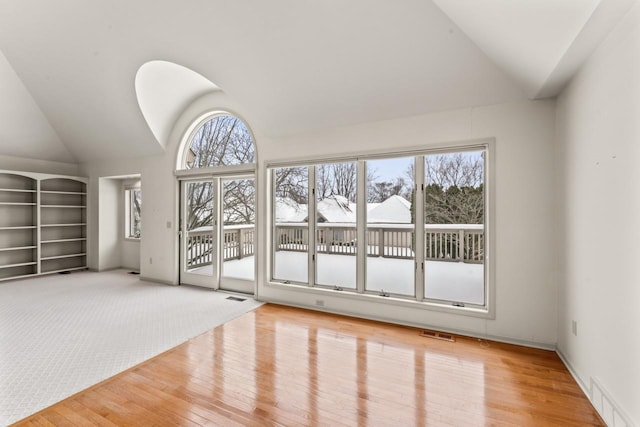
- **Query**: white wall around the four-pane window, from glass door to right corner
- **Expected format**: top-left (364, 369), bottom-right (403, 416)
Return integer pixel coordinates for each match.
top-left (259, 101), bottom-right (557, 347)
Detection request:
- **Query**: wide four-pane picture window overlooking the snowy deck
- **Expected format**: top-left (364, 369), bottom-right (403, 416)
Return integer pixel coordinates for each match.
top-left (270, 145), bottom-right (488, 309)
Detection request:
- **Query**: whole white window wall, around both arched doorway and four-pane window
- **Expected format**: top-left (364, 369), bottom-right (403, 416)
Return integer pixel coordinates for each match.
top-left (82, 95), bottom-right (557, 347)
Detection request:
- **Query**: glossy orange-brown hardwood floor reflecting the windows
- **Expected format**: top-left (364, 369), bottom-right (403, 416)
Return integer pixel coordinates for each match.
top-left (17, 304), bottom-right (604, 426)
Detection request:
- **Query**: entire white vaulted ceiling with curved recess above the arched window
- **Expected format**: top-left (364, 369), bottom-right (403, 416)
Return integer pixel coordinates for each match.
top-left (0, 0), bottom-right (636, 162)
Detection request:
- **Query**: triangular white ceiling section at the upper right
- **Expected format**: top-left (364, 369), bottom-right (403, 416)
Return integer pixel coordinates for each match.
top-left (433, 0), bottom-right (634, 98)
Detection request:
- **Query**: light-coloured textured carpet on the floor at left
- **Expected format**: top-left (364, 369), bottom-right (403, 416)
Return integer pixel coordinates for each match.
top-left (0, 270), bottom-right (260, 425)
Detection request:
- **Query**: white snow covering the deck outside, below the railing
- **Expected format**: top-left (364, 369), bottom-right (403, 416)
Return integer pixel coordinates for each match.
top-left (191, 251), bottom-right (484, 305)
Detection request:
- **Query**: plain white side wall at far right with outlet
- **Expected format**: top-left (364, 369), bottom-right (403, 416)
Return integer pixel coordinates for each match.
top-left (557, 4), bottom-right (640, 425)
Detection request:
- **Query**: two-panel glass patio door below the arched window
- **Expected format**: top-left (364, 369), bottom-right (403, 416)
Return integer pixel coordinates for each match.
top-left (180, 176), bottom-right (256, 294)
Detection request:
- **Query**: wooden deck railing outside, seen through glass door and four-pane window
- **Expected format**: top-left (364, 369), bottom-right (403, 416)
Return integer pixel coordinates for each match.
top-left (187, 223), bottom-right (485, 268)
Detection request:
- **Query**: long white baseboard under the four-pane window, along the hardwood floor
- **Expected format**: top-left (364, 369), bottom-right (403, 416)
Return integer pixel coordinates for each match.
top-left (257, 297), bottom-right (556, 351)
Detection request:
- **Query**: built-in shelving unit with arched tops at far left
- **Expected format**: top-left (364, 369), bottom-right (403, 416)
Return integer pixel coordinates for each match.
top-left (0, 170), bottom-right (87, 280)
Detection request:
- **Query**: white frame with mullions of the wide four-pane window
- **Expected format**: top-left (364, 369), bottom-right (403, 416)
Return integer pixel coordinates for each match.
top-left (265, 138), bottom-right (495, 318)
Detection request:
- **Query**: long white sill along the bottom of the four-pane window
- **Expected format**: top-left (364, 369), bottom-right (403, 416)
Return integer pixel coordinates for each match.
top-left (266, 281), bottom-right (495, 319)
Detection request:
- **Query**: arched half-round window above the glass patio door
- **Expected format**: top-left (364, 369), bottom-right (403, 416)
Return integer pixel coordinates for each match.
top-left (183, 114), bottom-right (255, 169)
